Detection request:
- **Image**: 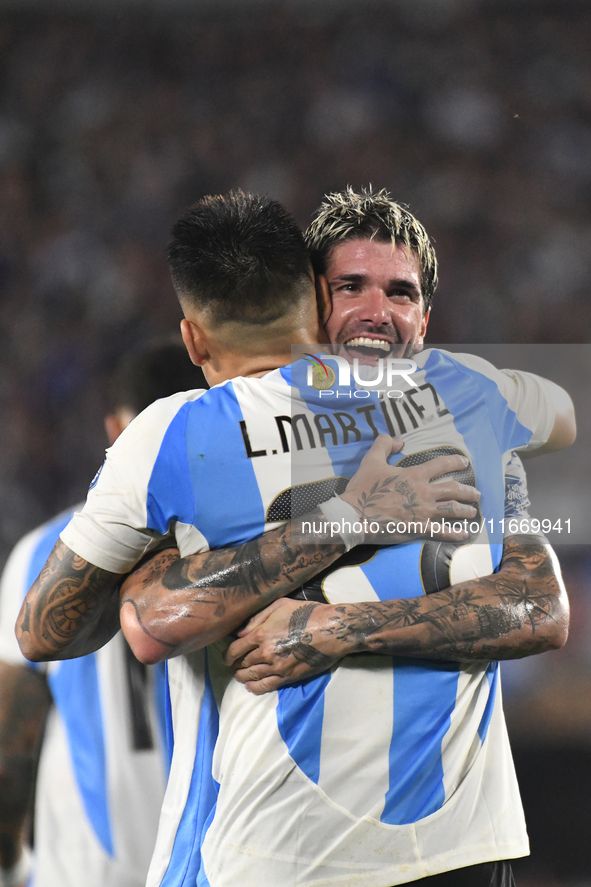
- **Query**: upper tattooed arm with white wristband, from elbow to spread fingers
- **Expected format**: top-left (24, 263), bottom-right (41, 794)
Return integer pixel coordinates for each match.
top-left (121, 436), bottom-right (480, 662)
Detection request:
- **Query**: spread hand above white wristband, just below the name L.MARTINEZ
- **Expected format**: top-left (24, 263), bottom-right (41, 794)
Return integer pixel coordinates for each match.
top-left (341, 434), bottom-right (480, 545)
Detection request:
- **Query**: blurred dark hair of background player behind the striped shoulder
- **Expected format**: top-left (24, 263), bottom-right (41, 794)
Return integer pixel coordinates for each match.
top-left (109, 337), bottom-right (208, 415)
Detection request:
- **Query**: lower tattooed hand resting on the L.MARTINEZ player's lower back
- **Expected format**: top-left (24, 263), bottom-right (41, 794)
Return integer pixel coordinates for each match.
top-left (224, 599), bottom-right (347, 696)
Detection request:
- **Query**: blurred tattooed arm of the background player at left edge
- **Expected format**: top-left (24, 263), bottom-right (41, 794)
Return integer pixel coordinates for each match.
top-left (0, 661), bottom-right (51, 869)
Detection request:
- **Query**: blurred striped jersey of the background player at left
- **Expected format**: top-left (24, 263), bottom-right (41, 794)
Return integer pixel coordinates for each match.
top-left (0, 506), bottom-right (169, 887)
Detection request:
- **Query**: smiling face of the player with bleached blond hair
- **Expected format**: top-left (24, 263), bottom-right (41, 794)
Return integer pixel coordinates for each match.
top-left (326, 238), bottom-right (429, 362)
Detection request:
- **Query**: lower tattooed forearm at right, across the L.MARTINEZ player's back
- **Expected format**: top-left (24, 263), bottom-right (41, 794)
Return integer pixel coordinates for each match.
top-left (314, 537), bottom-right (568, 661)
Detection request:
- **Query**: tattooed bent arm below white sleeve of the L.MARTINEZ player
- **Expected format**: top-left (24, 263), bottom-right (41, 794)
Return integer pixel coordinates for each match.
top-left (16, 540), bottom-right (121, 661)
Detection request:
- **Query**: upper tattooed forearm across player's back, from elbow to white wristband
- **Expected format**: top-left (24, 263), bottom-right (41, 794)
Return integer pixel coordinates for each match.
top-left (121, 510), bottom-right (344, 661)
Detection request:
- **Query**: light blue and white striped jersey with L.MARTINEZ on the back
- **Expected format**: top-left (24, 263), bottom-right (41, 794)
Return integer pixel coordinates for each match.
top-left (62, 351), bottom-right (554, 887)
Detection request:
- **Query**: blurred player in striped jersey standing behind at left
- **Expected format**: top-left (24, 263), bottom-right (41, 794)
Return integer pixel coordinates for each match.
top-left (0, 339), bottom-right (206, 887)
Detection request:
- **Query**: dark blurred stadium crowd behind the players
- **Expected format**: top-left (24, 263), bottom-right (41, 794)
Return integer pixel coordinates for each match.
top-left (0, 0), bottom-right (591, 887)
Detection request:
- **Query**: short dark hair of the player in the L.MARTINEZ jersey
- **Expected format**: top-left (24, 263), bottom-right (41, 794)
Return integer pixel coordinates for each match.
top-left (168, 191), bottom-right (312, 324)
